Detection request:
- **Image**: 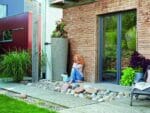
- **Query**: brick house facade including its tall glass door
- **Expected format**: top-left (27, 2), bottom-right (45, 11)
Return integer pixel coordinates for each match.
top-left (51, 0), bottom-right (150, 83)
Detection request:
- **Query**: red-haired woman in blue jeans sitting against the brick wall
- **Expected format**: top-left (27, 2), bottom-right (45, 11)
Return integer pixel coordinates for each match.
top-left (70, 54), bottom-right (84, 83)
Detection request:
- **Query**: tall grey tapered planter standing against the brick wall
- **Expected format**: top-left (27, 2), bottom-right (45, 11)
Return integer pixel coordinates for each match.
top-left (52, 38), bottom-right (68, 81)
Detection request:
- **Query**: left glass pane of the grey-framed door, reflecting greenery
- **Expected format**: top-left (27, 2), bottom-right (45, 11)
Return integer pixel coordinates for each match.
top-left (102, 15), bottom-right (117, 82)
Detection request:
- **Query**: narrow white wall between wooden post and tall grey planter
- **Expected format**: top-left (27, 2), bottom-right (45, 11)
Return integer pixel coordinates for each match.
top-left (37, 0), bottom-right (63, 80)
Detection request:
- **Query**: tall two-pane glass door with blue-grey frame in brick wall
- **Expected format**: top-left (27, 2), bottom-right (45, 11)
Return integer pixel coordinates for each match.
top-left (99, 11), bottom-right (136, 83)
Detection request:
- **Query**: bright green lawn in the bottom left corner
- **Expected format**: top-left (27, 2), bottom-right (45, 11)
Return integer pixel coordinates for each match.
top-left (0, 95), bottom-right (57, 113)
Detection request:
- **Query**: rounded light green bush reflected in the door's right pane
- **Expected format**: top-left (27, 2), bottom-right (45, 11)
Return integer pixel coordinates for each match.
top-left (125, 26), bottom-right (136, 51)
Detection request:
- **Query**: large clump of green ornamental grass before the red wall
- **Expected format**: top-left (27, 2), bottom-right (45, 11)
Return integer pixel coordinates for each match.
top-left (0, 51), bottom-right (31, 82)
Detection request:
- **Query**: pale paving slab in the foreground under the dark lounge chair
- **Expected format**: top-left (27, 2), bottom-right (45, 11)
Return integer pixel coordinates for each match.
top-left (59, 99), bottom-right (150, 113)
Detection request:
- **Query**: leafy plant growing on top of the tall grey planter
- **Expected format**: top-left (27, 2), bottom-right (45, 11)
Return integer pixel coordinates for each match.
top-left (52, 20), bottom-right (67, 38)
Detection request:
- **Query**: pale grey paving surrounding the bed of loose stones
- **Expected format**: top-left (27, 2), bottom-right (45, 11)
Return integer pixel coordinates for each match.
top-left (0, 82), bottom-right (150, 113)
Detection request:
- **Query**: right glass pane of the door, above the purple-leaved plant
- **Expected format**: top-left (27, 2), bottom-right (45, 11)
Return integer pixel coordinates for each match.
top-left (121, 11), bottom-right (136, 69)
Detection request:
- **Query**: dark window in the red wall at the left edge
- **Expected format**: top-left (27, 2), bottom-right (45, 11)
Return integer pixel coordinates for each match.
top-left (0, 30), bottom-right (12, 42)
